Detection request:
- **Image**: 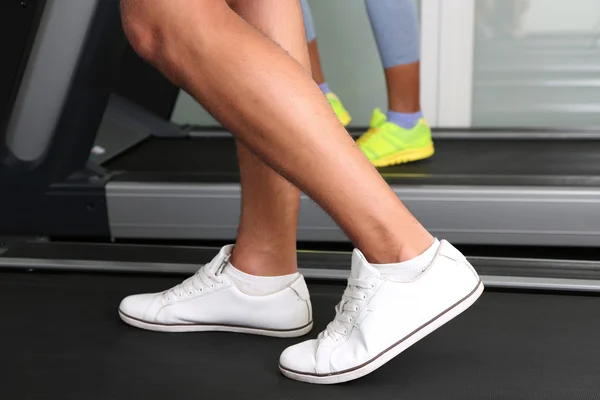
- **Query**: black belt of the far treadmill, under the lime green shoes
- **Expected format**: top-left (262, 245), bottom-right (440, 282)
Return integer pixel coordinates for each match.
top-left (106, 138), bottom-right (600, 186)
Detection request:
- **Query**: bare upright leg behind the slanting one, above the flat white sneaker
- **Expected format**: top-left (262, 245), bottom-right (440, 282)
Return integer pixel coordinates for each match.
top-left (232, 0), bottom-right (310, 276)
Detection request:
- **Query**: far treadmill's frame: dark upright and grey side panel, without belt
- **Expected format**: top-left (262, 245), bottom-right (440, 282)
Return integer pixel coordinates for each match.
top-left (0, 0), bottom-right (600, 253)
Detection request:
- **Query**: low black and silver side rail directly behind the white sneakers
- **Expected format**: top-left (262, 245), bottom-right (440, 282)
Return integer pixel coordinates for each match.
top-left (0, 240), bottom-right (600, 292)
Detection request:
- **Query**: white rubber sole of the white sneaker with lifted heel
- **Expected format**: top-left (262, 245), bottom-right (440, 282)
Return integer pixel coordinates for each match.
top-left (279, 281), bottom-right (484, 385)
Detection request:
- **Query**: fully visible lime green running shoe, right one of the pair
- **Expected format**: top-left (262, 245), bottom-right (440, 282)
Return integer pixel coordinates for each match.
top-left (357, 109), bottom-right (435, 167)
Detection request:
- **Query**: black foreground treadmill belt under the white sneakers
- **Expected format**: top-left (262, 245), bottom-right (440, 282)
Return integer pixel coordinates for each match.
top-left (0, 272), bottom-right (600, 400)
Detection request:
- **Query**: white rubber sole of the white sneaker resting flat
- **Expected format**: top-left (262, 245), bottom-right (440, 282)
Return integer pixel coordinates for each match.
top-left (119, 310), bottom-right (313, 338)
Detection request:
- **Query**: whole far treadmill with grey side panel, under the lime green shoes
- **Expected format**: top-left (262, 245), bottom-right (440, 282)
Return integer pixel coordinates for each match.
top-left (0, 0), bottom-right (600, 246)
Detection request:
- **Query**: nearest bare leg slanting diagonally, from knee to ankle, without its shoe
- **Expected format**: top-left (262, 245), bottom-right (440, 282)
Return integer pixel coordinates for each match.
top-left (122, 0), bottom-right (433, 263)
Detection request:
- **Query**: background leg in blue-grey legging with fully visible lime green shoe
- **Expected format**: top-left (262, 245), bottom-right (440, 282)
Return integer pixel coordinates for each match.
top-left (358, 0), bottom-right (434, 167)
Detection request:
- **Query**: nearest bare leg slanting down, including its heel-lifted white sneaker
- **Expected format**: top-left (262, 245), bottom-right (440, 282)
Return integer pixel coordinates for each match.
top-left (123, 0), bottom-right (483, 383)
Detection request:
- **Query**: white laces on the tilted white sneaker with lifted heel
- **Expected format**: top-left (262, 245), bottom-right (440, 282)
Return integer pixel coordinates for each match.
top-left (319, 278), bottom-right (374, 342)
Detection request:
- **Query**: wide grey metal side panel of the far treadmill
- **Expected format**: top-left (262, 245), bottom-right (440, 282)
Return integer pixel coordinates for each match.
top-left (106, 181), bottom-right (600, 246)
